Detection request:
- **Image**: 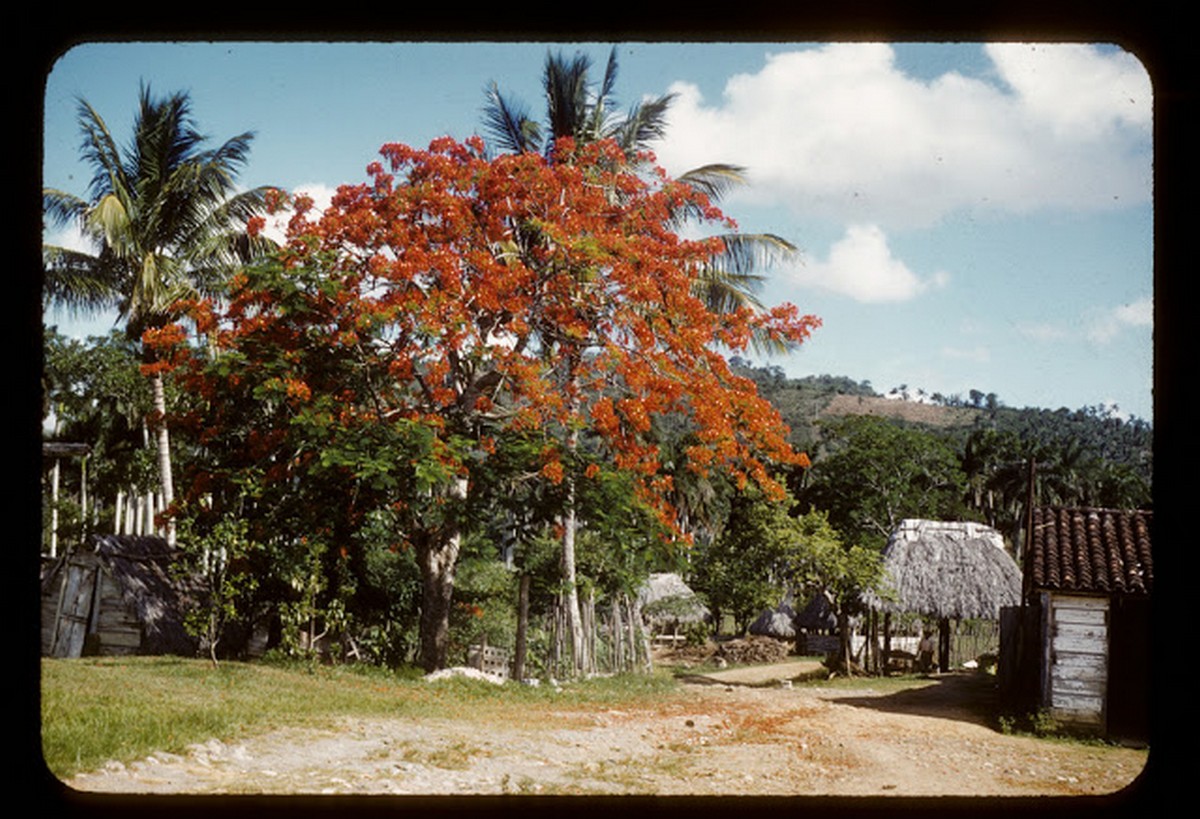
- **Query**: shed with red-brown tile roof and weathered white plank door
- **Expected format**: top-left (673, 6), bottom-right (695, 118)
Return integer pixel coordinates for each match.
top-left (1002, 507), bottom-right (1154, 739)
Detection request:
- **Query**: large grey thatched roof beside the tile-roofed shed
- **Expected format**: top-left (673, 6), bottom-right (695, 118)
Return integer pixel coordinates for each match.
top-left (866, 520), bottom-right (1021, 620)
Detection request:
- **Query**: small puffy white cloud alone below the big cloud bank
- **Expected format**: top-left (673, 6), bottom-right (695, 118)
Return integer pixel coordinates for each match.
top-left (792, 225), bottom-right (948, 303)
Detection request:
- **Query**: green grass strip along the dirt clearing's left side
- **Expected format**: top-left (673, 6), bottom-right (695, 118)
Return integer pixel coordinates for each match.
top-left (42, 657), bottom-right (678, 778)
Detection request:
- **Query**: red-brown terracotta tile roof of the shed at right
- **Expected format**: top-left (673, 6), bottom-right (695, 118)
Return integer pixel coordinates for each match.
top-left (1026, 507), bottom-right (1154, 594)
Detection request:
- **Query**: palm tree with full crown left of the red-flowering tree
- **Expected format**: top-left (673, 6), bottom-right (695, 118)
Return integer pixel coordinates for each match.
top-left (42, 85), bottom-right (270, 542)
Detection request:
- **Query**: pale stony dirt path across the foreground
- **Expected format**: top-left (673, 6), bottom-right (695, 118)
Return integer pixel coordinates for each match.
top-left (60, 669), bottom-right (1147, 796)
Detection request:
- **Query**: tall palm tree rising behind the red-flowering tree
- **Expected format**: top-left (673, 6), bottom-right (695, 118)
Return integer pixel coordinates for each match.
top-left (484, 48), bottom-right (796, 669)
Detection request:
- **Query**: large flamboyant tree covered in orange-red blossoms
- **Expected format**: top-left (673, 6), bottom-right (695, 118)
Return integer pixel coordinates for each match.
top-left (166, 138), bottom-right (818, 670)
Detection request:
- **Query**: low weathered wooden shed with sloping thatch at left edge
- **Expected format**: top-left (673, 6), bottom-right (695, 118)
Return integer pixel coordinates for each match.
top-left (42, 534), bottom-right (197, 657)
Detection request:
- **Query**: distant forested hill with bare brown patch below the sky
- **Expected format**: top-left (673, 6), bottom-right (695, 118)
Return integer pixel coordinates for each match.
top-left (733, 359), bottom-right (1153, 484)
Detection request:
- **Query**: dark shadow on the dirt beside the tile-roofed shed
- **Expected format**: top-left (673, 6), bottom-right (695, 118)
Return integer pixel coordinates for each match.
top-left (828, 671), bottom-right (997, 728)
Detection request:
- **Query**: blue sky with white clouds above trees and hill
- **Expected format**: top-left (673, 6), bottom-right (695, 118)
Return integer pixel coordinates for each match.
top-left (43, 42), bottom-right (1153, 419)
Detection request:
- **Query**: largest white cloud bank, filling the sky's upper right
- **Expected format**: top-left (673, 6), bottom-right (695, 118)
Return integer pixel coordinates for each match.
top-left (656, 43), bottom-right (1151, 228)
